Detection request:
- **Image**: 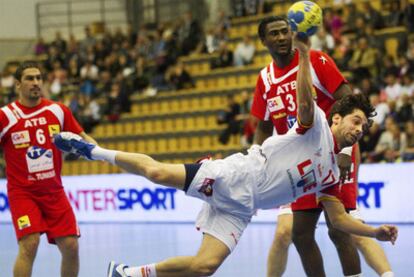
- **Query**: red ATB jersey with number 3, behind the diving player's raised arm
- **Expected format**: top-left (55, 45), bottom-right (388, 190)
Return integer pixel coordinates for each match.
top-left (251, 50), bottom-right (346, 135)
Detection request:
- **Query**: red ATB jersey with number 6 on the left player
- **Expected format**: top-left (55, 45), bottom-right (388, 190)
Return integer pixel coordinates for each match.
top-left (0, 99), bottom-right (83, 193)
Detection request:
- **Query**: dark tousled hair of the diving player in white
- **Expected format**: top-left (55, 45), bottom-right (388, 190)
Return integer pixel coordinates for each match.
top-left (328, 93), bottom-right (377, 132)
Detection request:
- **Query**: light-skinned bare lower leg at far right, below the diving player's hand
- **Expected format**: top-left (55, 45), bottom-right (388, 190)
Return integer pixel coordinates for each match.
top-left (352, 236), bottom-right (392, 275)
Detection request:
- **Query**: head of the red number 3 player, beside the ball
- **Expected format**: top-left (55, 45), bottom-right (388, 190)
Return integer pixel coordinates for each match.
top-left (258, 16), bottom-right (293, 56)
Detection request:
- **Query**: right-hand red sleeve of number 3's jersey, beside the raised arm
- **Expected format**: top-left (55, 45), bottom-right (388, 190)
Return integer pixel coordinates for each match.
top-left (312, 51), bottom-right (348, 94)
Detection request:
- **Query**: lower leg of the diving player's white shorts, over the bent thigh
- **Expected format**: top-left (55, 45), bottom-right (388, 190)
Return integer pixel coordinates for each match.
top-left (196, 203), bottom-right (250, 252)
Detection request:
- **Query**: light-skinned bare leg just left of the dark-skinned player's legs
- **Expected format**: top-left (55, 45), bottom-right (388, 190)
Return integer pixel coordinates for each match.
top-left (267, 214), bottom-right (293, 277)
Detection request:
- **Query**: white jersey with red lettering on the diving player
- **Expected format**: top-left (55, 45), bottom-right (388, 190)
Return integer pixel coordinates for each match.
top-left (255, 101), bottom-right (339, 209)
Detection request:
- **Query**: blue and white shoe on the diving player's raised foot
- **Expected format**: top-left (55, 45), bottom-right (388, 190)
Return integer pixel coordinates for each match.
top-left (53, 132), bottom-right (96, 160)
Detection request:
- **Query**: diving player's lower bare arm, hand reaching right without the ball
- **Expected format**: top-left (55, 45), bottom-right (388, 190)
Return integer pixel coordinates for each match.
top-left (321, 197), bottom-right (398, 244)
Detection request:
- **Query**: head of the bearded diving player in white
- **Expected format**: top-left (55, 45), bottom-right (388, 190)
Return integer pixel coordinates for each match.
top-left (329, 94), bottom-right (376, 148)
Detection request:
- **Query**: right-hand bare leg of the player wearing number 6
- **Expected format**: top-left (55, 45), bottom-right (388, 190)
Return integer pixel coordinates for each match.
top-left (55, 236), bottom-right (79, 277)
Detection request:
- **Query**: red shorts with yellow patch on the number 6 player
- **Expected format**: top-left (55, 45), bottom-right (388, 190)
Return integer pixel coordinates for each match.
top-left (8, 189), bottom-right (80, 243)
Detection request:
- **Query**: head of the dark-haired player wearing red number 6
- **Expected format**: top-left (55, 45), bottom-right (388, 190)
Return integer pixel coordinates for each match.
top-left (14, 61), bottom-right (43, 101)
